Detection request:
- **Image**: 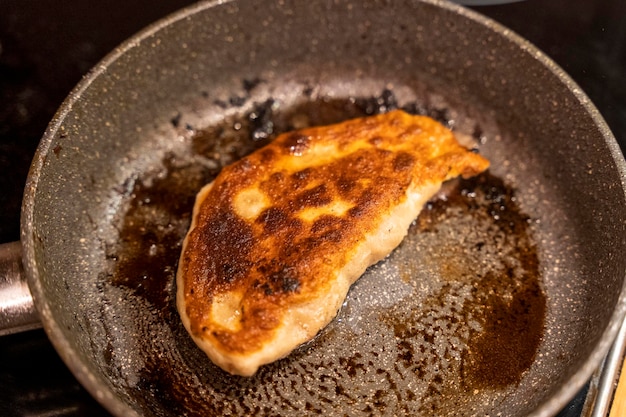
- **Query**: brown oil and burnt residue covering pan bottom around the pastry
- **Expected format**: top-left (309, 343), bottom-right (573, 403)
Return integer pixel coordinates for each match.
top-left (107, 90), bottom-right (545, 416)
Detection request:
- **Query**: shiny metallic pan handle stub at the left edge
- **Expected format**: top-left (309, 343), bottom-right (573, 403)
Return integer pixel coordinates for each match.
top-left (0, 242), bottom-right (41, 336)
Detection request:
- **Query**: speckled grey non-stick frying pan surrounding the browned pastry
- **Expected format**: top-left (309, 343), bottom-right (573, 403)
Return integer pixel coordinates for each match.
top-left (0, 0), bottom-right (626, 416)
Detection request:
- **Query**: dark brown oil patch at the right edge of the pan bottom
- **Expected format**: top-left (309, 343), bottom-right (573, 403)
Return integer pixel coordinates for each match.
top-left (456, 175), bottom-right (546, 388)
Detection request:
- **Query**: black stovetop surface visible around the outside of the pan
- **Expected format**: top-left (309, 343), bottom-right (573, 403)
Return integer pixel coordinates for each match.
top-left (0, 0), bottom-right (626, 417)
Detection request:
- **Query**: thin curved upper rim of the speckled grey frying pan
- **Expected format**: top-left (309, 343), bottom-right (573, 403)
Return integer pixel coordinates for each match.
top-left (21, 0), bottom-right (626, 417)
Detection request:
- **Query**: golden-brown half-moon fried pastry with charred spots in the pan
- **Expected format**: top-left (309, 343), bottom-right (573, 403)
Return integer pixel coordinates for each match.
top-left (177, 110), bottom-right (489, 376)
